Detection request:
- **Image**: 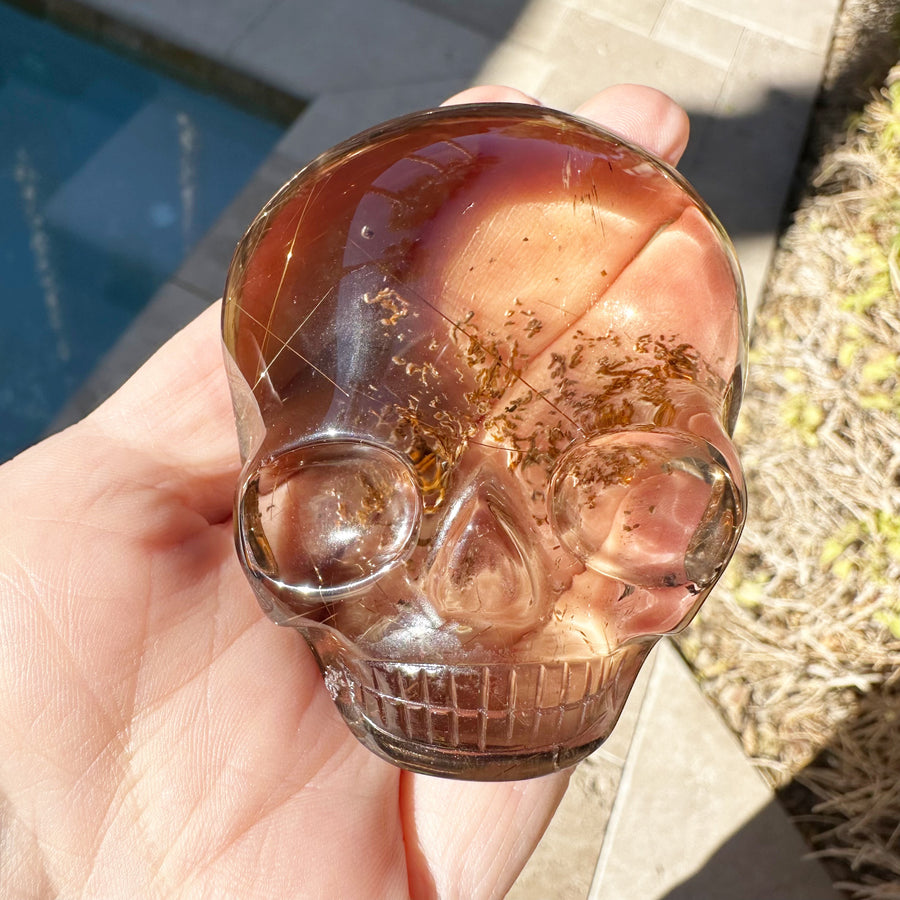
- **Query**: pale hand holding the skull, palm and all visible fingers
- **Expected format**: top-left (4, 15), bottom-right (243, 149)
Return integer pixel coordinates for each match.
top-left (0, 86), bottom-right (688, 898)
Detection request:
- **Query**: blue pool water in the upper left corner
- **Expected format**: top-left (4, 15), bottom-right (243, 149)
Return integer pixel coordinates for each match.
top-left (0, 4), bottom-right (281, 461)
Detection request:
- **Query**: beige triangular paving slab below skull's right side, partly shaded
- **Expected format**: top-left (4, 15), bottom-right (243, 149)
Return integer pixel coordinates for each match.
top-left (589, 642), bottom-right (838, 900)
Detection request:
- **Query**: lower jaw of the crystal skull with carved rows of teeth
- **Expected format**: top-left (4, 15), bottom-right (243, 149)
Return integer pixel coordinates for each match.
top-left (295, 623), bottom-right (658, 781)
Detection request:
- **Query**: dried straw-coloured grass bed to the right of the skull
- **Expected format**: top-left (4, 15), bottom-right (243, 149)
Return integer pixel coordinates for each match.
top-left (680, 66), bottom-right (900, 900)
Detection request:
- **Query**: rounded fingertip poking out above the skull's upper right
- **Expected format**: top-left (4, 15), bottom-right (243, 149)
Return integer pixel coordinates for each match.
top-left (575, 84), bottom-right (690, 166)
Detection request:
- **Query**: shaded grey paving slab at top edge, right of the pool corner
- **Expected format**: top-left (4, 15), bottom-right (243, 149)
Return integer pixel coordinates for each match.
top-left (227, 0), bottom-right (493, 97)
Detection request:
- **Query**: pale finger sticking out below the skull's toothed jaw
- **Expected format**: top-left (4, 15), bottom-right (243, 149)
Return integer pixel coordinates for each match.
top-left (400, 771), bottom-right (570, 898)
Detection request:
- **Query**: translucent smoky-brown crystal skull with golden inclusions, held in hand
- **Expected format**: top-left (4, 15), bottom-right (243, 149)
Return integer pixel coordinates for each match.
top-left (223, 104), bottom-right (746, 780)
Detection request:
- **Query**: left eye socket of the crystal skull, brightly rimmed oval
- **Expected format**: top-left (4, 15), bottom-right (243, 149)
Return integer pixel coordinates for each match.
top-left (238, 440), bottom-right (422, 600)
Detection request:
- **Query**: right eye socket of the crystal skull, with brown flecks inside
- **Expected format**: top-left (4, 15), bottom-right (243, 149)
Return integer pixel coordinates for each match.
top-left (549, 428), bottom-right (744, 590)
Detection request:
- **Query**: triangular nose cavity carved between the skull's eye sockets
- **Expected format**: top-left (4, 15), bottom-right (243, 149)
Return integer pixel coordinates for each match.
top-left (426, 484), bottom-right (542, 640)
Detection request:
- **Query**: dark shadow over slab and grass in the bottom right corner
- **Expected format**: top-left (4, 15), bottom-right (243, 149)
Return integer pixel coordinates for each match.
top-left (665, 683), bottom-right (900, 900)
